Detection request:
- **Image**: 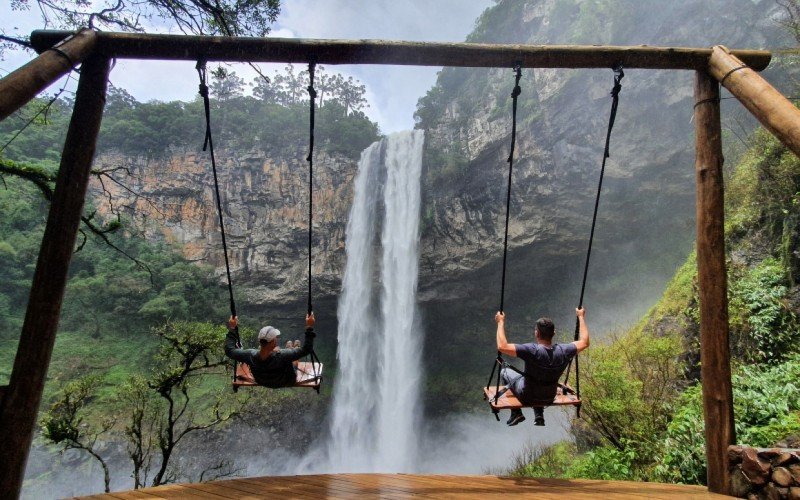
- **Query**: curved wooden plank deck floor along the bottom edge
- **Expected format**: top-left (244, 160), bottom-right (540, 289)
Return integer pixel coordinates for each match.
top-left (78, 474), bottom-right (727, 500)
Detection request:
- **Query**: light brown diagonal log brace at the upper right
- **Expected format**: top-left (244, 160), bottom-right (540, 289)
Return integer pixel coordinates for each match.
top-left (708, 45), bottom-right (800, 156)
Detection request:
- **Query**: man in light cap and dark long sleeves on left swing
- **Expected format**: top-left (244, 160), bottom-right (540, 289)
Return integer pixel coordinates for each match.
top-left (225, 313), bottom-right (316, 388)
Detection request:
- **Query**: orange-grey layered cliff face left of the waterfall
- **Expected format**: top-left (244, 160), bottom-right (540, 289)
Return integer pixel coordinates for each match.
top-left (95, 147), bottom-right (357, 305)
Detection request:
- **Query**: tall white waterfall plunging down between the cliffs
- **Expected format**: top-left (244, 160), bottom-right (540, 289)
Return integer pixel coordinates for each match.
top-left (327, 131), bottom-right (424, 472)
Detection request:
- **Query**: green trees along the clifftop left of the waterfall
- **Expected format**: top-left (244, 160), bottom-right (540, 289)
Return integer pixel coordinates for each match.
top-left (0, 66), bottom-right (379, 163)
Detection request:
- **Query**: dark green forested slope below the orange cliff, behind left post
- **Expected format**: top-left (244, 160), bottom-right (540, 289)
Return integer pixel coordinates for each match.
top-left (0, 178), bottom-right (225, 386)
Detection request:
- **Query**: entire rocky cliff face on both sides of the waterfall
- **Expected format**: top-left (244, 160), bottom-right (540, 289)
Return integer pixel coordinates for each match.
top-left (92, 0), bottom-right (790, 342)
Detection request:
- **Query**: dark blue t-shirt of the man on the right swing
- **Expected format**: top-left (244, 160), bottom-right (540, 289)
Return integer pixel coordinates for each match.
top-left (515, 343), bottom-right (578, 401)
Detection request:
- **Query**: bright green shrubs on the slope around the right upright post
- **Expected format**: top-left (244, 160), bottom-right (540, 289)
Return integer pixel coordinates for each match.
top-left (514, 131), bottom-right (800, 484)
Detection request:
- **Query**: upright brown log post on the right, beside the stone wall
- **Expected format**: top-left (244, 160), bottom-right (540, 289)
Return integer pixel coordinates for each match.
top-left (694, 70), bottom-right (736, 494)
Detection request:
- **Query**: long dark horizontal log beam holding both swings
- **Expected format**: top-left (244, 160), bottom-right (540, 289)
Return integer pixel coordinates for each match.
top-left (31, 31), bottom-right (772, 71)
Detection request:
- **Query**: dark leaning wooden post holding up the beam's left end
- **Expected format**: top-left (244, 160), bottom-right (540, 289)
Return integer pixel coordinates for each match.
top-left (0, 57), bottom-right (109, 498)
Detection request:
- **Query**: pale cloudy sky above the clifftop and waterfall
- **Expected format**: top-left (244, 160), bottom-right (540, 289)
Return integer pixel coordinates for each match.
top-left (0, 0), bottom-right (494, 133)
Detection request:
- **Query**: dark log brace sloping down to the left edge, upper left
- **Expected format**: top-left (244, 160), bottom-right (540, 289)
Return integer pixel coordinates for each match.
top-left (0, 30), bottom-right (97, 120)
